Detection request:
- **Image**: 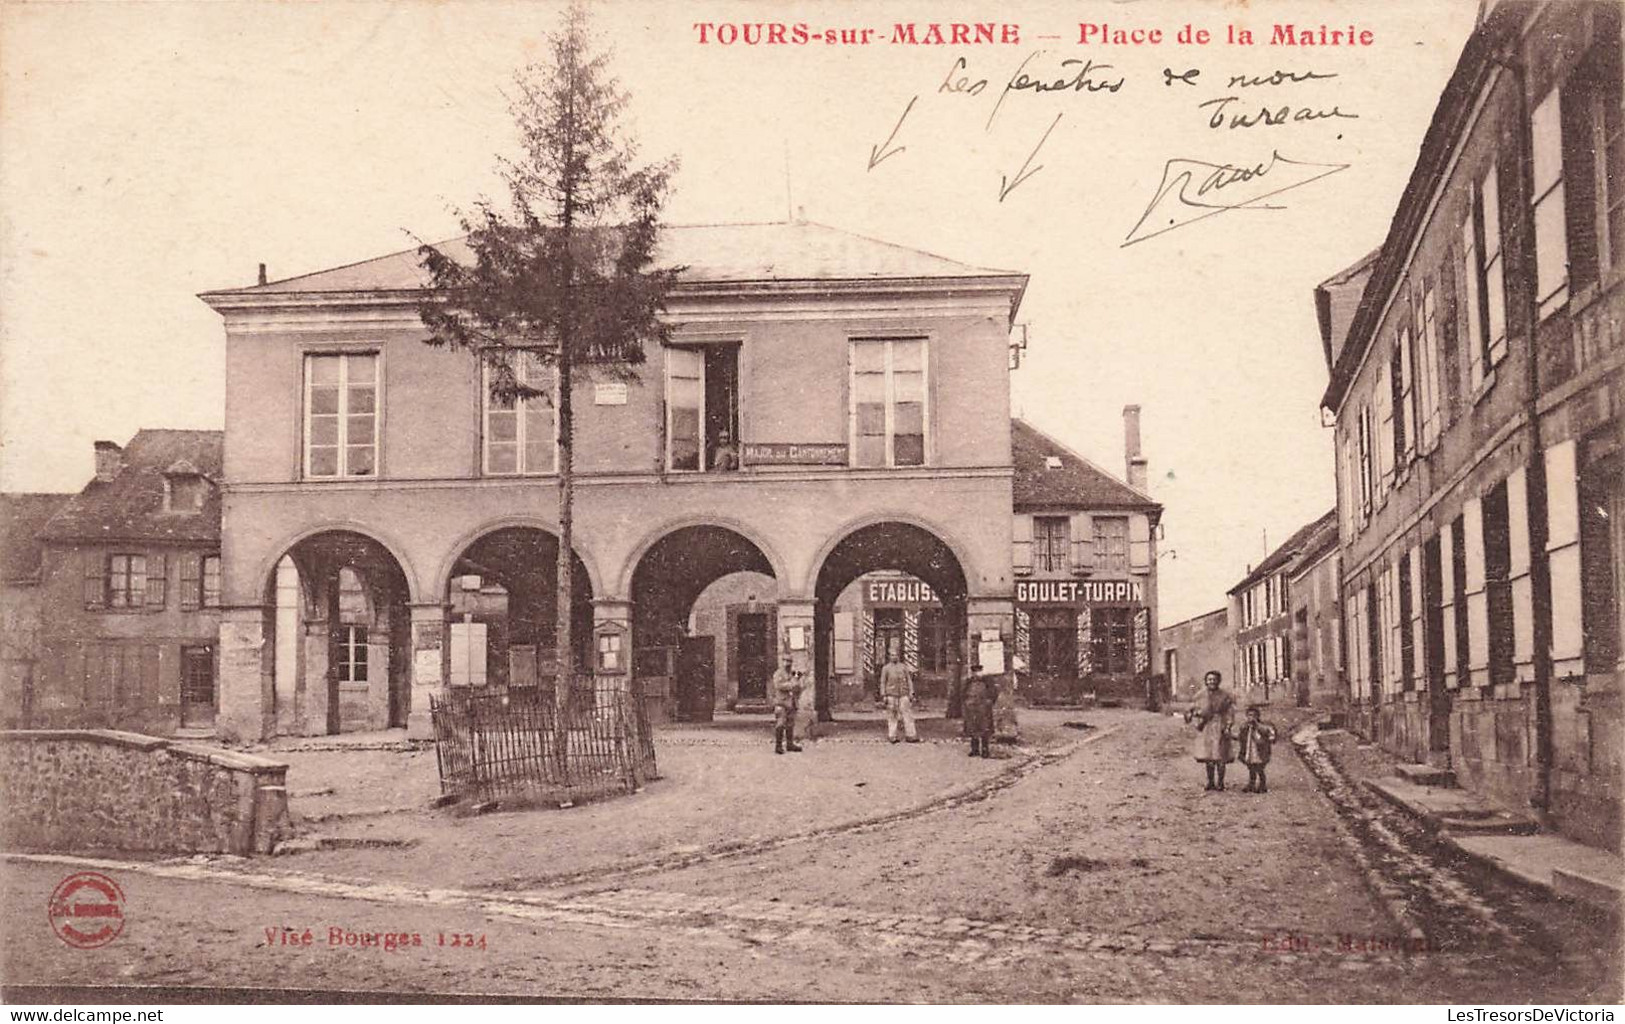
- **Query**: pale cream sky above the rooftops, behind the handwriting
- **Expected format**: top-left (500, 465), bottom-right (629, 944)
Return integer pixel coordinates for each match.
top-left (0, 0), bottom-right (1477, 624)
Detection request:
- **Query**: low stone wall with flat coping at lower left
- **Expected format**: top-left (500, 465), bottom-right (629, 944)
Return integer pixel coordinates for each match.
top-left (0, 730), bottom-right (288, 855)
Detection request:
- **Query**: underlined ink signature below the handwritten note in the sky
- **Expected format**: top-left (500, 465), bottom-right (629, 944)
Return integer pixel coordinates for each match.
top-left (1118, 153), bottom-right (1349, 249)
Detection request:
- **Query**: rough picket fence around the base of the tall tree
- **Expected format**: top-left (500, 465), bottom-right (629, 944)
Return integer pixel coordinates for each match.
top-left (429, 679), bottom-right (660, 803)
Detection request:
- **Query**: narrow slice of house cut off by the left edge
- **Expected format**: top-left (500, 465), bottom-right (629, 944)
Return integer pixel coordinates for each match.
top-left (0, 492), bottom-right (73, 728)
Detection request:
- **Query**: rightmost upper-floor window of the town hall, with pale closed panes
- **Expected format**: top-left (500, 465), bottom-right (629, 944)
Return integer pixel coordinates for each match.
top-left (852, 338), bottom-right (930, 466)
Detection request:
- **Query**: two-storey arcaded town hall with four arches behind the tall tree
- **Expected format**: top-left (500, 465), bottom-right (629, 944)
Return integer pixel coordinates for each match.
top-left (202, 223), bottom-right (1027, 738)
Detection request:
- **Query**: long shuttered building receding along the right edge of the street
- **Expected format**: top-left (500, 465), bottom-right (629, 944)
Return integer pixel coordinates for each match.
top-left (1318, 2), bottom-right (1625, 848)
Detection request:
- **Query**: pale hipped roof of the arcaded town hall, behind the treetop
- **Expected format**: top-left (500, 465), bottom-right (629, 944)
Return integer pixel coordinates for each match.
top-left (199, 221), bottom-right (1024, 294)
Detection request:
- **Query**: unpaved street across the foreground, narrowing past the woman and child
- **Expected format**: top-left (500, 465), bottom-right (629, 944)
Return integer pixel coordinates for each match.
top-left (5, 712), bottom-right (1620, 1003)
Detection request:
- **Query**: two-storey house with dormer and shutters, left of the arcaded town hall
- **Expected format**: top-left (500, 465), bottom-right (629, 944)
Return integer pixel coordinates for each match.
top-left (21, 431), bottom-right (221, 735)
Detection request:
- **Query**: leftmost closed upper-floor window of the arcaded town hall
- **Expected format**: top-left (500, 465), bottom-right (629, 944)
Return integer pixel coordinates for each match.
top-left (306, 353), bottom-right (379, 478)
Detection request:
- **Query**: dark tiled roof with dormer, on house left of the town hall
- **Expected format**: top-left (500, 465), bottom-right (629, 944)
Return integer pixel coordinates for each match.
top-left (42, 431), bottom-right (223, 543)
